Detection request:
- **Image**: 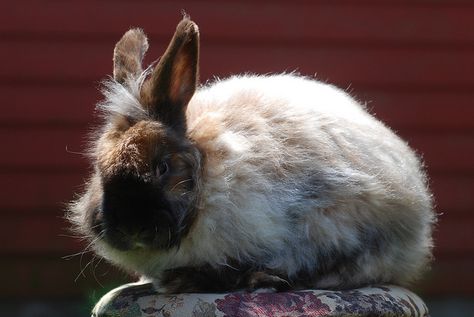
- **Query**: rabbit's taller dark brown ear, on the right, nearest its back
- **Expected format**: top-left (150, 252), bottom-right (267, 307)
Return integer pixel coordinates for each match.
top-left (141, 17), bottom-right (199, 132)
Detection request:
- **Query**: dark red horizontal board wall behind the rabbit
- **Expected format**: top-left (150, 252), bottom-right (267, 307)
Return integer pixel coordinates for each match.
top-left (0, 0), bottom-right (474, 316)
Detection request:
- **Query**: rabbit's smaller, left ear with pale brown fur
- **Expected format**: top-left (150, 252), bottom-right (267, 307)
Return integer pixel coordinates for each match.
top-left (114, 29), bottom-right (148, 84)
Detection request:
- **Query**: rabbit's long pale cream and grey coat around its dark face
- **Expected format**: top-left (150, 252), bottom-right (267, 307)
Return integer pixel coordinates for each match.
top-left (72, 74), bottom-right (435, 291)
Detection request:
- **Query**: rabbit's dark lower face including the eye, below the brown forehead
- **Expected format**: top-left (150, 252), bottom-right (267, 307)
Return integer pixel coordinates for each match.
top-left (95, 142), bottom-right (199, 250)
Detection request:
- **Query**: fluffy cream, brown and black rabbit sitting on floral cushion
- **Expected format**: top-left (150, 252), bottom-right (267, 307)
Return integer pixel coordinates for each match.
top-left (68, 17), bottom-right (436, 293)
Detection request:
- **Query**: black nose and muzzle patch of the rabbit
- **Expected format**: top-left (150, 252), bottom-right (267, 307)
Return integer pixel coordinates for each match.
top-left (99, 175), bottom-right (179, 250)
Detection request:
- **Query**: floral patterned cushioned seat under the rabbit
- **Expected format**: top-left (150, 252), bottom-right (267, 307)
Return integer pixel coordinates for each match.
top-left (92, 283), bottom-right (428, 317)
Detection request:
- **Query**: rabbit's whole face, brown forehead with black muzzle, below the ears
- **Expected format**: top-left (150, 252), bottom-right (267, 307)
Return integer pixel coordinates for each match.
top-left (90, 121), bottom-right (200, 250)
